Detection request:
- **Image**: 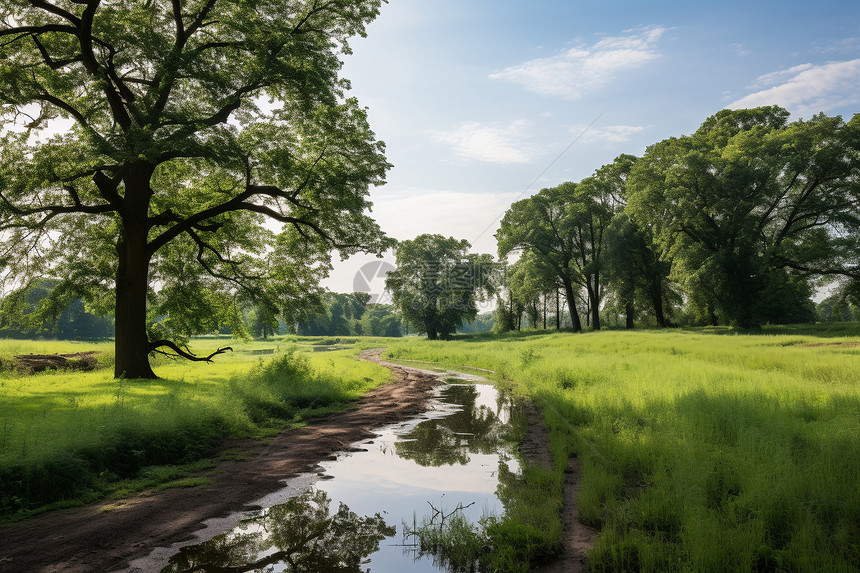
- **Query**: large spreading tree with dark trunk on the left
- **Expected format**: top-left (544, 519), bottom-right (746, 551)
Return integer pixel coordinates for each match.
top-left (0, 0), bottom-right (388, 377)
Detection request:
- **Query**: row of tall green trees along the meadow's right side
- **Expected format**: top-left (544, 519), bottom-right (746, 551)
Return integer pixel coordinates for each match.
top-left (496, 106), bottom-right (860, 330)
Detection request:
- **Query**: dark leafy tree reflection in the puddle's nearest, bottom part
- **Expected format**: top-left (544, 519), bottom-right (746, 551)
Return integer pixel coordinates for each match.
top-left (162, 489), bottom-right (395, 573)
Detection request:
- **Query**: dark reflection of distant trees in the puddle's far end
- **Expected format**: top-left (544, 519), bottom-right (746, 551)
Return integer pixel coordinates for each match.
top-left (394, 384), bottom-right (510, 467)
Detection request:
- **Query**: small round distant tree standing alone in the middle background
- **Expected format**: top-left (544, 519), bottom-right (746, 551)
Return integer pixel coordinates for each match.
top-left (385, 234), bottom-right (496, 340)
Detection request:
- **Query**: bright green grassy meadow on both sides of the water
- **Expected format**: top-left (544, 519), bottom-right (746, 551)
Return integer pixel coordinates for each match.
top-left (0, 324), bottom-right (860, 572)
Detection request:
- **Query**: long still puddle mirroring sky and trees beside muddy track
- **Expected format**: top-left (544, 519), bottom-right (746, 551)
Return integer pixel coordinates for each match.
top-left (129, 371), bottom-right (519, 573)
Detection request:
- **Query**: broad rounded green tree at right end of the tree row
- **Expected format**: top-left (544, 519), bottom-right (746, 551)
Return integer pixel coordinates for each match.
top-left (628, 106), bottom-right (860, 328)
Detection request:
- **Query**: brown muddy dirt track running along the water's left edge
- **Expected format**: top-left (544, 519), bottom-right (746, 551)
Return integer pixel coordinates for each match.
top-left (0, 349), bottom-right (439, 573)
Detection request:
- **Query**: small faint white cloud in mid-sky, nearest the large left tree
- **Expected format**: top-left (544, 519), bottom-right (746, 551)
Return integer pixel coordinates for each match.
top-left (430, 120), bottom-right (534, 163)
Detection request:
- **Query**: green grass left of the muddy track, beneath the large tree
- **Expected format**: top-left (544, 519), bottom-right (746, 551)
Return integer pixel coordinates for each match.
top-left (0, 337), bottom-right (389, 519)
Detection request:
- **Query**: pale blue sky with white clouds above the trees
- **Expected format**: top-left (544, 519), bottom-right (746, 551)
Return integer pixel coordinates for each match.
top-left (325, 0), bottom-right (860, 292)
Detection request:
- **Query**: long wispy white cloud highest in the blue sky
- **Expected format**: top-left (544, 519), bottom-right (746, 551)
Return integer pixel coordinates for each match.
top-left (490, 27), bottom-right (665, 99)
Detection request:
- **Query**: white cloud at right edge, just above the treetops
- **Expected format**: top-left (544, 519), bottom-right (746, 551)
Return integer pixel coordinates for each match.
top-left (728, 59), bottom-right (860, 115)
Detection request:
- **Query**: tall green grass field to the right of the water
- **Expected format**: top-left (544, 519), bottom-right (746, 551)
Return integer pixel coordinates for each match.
top-left (389, 329), bottom-right (860, 571)
